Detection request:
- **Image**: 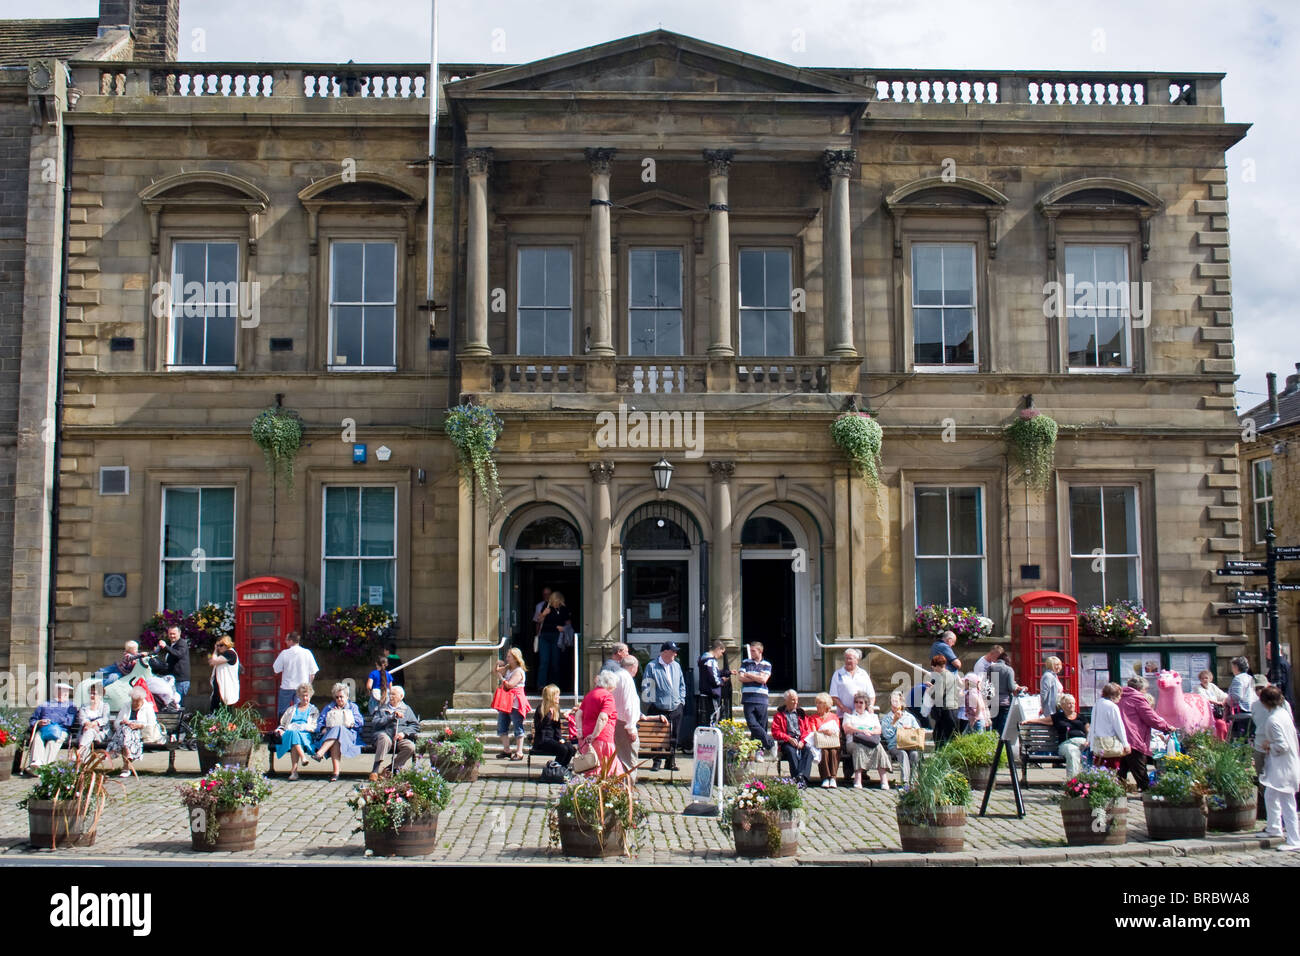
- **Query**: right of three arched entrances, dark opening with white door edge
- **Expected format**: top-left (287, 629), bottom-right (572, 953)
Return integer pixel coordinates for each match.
top-left (740, 505), bottom-right (822, 692)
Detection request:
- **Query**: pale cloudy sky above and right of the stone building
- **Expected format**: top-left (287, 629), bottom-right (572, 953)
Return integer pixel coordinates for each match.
top-left (20, 0), bottom-right (1300, 410)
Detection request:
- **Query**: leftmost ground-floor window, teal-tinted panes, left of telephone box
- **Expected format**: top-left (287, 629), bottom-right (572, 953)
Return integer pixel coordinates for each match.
top-left (163, 488), bottom-right (235, 611)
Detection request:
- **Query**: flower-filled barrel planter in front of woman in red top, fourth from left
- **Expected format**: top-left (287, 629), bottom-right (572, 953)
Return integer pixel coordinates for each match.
top-left (546, 757), bottom-right (646, 858)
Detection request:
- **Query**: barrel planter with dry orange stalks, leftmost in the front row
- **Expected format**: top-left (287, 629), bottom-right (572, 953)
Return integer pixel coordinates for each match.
top-left (18, 752), bottom-right (108, 849)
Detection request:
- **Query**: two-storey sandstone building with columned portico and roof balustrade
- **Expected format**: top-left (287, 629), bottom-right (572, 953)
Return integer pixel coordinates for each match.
top-left (2, 16), bottom-right (1245, 706)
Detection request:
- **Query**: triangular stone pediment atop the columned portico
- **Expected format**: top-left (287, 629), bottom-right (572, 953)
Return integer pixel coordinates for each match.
top-left (446, 30), bottom-right (866, 98)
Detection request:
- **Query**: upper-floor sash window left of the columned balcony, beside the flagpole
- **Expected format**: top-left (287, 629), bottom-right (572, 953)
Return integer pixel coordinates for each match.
top-left (329, 241), bottom-right (398, 368)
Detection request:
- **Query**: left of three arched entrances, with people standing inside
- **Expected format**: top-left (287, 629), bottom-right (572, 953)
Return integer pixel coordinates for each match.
top-left (502, 505), bottom-right (582, 695)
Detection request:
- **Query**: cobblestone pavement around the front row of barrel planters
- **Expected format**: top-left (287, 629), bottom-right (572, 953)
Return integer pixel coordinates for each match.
top-left (0, 754), bottom-right (1284, 866)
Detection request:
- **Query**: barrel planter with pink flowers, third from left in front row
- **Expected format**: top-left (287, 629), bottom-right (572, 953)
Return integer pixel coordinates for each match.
top-left (347, 760), bottom-right (451, 856)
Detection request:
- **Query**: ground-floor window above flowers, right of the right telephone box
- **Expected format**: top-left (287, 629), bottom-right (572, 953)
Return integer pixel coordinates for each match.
top-left (1070, 485), bottom-right (1141, 607)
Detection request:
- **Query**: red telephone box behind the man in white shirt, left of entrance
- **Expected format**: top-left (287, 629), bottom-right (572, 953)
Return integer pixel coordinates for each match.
top-left (235, 578), bottom-right (300, 718)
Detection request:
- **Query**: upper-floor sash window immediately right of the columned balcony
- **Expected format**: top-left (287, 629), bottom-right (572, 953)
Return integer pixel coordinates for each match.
top-left (911, 242), bottom-right (979, 365)
